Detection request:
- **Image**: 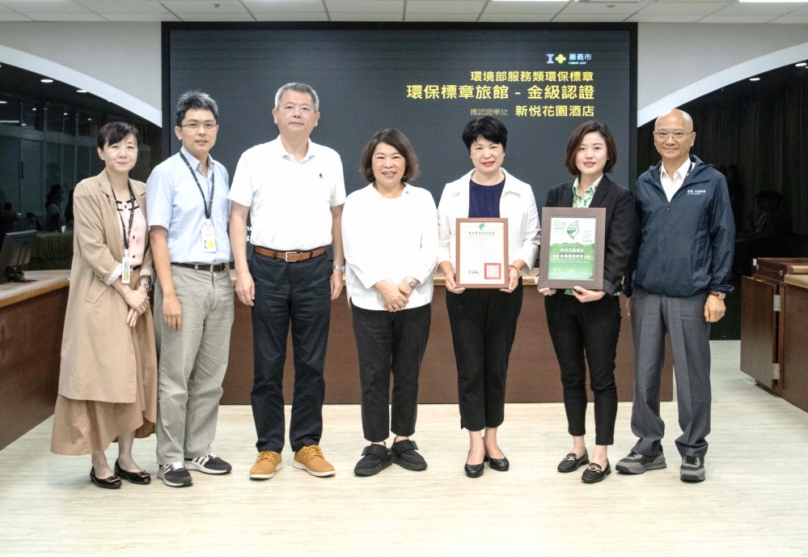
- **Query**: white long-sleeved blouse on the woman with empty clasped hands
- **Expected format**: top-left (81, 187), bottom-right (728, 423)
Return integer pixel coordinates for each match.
top-left (342, 184), bottom-right (438, 310)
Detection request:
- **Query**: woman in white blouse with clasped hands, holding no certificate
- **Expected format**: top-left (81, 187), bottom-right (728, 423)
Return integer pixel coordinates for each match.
top-left (342, 129), bottom-right (438, 476)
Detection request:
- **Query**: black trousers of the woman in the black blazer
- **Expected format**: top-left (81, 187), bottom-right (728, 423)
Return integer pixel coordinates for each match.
top-left (544, 294), bottom-right (621, 445)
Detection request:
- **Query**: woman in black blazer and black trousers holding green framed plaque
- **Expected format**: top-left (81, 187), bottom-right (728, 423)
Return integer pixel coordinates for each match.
top-left (539, 121), bottom-right (635, 483)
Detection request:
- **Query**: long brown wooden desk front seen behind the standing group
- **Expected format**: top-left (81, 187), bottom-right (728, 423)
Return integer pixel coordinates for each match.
top-left (222, 272), bottom-right (673, 404)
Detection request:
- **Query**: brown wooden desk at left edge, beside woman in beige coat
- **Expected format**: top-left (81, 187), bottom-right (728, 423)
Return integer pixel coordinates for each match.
top-left (0, 271), bottom-right (70, 449)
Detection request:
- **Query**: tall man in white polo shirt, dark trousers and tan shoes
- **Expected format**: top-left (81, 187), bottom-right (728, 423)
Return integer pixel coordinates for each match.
top-left (230, 83), bottom-right (345, 480)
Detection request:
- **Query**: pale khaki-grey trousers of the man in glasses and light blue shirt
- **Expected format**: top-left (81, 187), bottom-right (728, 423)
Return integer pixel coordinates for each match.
top-left (154, 265), bottom-right (234, 464)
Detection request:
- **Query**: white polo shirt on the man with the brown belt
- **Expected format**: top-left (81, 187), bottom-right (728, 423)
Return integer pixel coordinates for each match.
top-left (228, 137), bottom-right (345, 251)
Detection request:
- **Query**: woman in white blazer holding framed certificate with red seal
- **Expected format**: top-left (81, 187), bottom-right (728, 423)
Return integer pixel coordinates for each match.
top-left (438, 116), bottom-right (539, 478)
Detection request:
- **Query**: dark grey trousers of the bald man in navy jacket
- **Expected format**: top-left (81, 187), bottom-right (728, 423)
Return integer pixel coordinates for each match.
top-left (631, 288), bottom-right (712, 458)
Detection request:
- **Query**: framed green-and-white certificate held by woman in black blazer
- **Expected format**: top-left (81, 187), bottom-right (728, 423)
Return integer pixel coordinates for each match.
top-left (539, 207), bottom-right (606, 290)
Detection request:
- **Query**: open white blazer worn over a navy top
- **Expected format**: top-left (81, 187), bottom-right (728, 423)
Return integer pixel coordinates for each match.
top-left (438, 168), bottom-right (539, 276)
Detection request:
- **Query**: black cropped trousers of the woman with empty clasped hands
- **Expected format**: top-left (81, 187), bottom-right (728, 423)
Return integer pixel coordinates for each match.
top-left (351, 304), bottom-right (432, 443)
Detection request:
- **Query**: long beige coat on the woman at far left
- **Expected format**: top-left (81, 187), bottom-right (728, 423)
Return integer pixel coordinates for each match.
top-left (59, 170), bottom-right (153, 403)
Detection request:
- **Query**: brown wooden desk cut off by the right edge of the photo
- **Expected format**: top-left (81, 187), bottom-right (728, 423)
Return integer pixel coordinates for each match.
top-left (781, 274), bottom-right (808, 412)
